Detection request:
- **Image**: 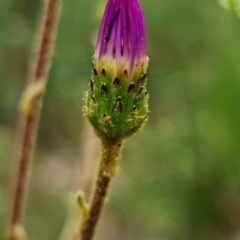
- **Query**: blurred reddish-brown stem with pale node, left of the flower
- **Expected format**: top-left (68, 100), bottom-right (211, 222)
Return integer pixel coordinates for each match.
top-left (7, 0), bottom-right (61, 240)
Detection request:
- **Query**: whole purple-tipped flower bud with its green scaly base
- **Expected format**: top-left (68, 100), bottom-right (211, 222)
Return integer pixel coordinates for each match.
top-left (85, 0), bottom-right (148, 138)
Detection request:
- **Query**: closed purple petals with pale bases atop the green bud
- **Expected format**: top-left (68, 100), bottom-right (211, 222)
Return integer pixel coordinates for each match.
top-left (95, 0), bottom-right (147, 79)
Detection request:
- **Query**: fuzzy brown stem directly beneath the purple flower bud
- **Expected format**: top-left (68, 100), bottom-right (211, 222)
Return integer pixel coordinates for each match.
top-left (81, 138), bottom-right (122, 240)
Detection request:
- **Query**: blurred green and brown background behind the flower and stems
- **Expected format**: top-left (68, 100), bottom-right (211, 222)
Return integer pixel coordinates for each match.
top-left (0, 0), bottom-right (240, 240)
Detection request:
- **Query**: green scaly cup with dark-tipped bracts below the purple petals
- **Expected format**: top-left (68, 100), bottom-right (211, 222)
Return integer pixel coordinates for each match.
top-left (85, 56), bottom-right (148, 138)
